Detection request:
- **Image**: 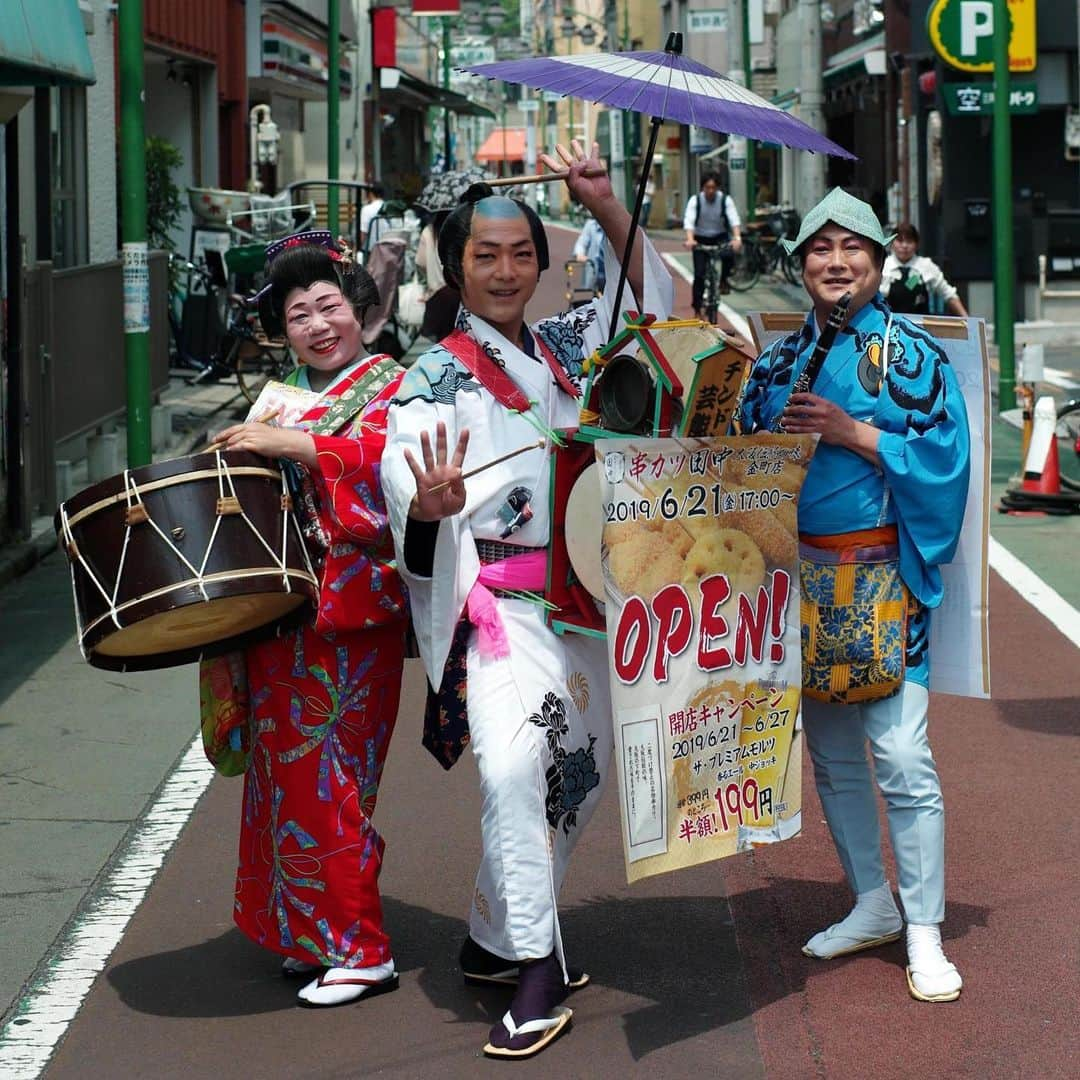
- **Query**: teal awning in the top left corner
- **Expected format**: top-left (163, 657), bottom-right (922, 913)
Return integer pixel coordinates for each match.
top-left (0, 0), bottom-right (96, 86)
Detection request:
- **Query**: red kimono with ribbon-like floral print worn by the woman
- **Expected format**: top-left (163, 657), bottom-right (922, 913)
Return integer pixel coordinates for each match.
top-left (234, 357), bottom-right (407, 968)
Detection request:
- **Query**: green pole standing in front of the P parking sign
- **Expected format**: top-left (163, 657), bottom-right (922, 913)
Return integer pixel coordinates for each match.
top-left (994, 0), bottom-right (1016, 410)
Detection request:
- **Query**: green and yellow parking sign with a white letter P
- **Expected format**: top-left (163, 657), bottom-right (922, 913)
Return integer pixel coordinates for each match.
top-left (927, 0), bottom-right (1038, 71)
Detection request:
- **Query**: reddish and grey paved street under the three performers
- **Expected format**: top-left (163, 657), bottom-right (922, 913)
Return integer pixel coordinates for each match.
top-left (0, 228), bottom-right (1080, 1080)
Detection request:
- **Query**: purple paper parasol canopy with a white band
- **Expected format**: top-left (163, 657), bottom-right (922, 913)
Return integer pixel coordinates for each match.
top-left (461, 44), bottom-right (854, 158)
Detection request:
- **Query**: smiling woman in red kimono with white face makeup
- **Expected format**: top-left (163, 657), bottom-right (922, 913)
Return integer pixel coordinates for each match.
top-left (210, 232), bottom-right (407, 1005)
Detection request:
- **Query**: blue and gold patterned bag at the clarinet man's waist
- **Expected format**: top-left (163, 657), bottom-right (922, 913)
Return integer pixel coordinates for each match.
top-left (799, 526), bottom-right (914, 705)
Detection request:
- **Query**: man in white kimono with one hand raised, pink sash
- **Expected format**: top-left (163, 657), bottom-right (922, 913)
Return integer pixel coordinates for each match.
top-left (382, 143), bottom-right (673, 1057)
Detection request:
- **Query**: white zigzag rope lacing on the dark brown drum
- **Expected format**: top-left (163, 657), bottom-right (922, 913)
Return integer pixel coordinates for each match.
top-left (59, 450), bottom-right (314, 643)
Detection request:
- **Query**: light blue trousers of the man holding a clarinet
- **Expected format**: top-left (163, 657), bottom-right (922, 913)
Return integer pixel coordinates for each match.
top-left (802, 683), bottom-right (945, 923)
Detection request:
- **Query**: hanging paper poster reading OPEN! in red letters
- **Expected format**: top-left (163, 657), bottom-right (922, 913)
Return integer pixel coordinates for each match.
top-left (596, 434), bottom-right (816, 881)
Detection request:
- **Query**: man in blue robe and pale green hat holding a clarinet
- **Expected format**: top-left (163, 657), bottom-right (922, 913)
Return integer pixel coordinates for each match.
top-left (741, 188), bottom-right (969, 1001)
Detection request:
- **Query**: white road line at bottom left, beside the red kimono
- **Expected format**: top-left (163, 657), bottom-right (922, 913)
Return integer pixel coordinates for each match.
top-left (0, 734), bottom-right (214, 1080)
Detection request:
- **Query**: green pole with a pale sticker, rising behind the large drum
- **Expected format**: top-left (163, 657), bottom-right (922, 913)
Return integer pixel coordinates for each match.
top-left (118, 0), bottom-right (153, 469)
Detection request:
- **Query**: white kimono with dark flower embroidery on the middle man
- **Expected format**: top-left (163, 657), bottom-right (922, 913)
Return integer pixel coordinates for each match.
top-left (382, 241), bottom-right (673, 960)
